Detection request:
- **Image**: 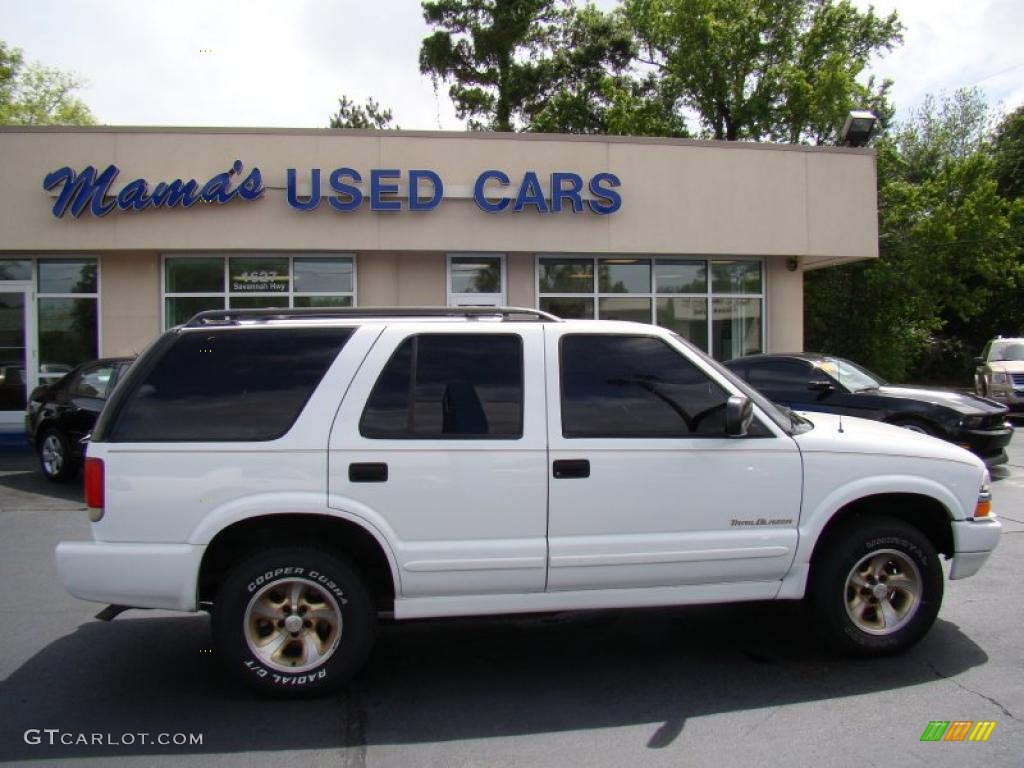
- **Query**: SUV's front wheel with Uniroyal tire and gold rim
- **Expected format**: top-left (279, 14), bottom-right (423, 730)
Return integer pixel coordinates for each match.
top-left (808, 517), bottom-right (943, 656)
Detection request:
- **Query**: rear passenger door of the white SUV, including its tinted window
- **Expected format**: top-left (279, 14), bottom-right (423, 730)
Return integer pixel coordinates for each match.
top-left (329, 324), bottom-right (547, 597)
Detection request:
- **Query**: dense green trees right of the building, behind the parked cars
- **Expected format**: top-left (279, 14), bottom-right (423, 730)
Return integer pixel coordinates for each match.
top-left (805, 90), bottom-right (1024, 385)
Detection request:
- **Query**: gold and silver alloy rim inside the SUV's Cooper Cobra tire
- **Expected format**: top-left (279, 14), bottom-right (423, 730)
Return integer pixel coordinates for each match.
top-left (243, 578), bottom-right (342, 673)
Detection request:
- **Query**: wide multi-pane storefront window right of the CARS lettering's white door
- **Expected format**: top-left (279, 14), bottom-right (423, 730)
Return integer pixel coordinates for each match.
top-left (537, 256), bottom-right (764, 360)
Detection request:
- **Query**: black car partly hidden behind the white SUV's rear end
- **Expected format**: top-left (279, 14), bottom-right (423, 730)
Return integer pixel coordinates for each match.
top-left (25, 357), bottom-right (132, 481)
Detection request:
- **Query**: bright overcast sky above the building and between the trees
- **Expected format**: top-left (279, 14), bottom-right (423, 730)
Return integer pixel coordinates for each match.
top-left (0, 0), bottom-right (1024, 130)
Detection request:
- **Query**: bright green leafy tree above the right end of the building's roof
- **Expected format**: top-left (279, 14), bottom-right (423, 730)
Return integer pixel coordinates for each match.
top-left (624, 0), bottom-right (902, 143)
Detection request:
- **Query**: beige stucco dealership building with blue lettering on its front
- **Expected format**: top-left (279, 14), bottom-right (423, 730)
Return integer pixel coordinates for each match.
top-left (0, 127), bottom-right (878, 423)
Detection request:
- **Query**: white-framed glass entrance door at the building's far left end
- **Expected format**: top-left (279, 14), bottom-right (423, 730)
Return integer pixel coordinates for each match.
top-left (0, 286), bottom-right (35, 422)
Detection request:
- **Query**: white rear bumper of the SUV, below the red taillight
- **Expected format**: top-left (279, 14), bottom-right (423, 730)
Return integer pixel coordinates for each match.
top-left (56, 542), bottom-right (206, 610)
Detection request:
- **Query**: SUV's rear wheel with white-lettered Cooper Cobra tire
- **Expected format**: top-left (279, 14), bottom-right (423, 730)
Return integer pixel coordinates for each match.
top-left (212, 547), bottom-right (377, 698)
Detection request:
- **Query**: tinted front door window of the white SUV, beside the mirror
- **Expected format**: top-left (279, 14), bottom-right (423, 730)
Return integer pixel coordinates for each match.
top-left (561, 334), bottom-right (728, 437)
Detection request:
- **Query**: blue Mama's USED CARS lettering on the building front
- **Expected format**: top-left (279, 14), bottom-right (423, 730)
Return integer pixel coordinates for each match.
top-left (43, 160), bottom-right (623, 218)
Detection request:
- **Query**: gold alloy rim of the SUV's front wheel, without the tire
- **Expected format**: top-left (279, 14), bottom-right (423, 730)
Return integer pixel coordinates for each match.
top-left (846, 549), bottom-right (923, 635)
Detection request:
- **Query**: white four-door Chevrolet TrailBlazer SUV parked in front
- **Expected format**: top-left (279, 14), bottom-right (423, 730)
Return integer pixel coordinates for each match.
top-left (56, 308), bottom-right (1001, 694)
